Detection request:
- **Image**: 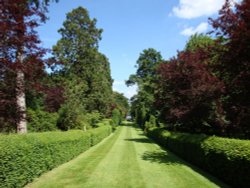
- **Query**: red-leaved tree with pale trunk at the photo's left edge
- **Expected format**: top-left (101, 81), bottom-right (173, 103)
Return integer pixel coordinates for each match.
top-left (0, 0), bottom-right (49, 133)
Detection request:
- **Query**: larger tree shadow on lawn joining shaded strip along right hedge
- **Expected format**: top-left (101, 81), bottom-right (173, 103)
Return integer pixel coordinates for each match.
top-left (141, 148), bottom-right (229, 188)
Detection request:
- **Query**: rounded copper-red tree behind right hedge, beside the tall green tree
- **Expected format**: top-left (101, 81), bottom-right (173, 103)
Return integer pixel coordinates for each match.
top-left (156, 51), bottom-right (225, 132)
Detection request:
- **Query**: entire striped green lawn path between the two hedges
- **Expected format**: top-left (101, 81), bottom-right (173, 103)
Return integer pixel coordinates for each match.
top-left (26, 126), bottom-right (229, 188)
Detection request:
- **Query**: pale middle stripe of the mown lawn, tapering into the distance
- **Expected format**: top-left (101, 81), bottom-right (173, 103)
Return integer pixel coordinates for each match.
top-left (81, 127), bottom-right (144, 188)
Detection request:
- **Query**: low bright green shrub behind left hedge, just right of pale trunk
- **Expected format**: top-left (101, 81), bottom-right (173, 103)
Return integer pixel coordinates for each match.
top-left (27, 109), bottom-right (58, 132)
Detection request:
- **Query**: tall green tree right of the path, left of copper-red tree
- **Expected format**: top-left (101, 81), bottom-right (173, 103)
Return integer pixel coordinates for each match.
top-left (126, 48), bottom-right (163, 127)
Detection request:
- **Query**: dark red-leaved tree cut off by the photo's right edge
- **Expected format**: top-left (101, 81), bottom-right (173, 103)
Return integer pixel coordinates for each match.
top-left (210, 0), bottom-right (250, 136)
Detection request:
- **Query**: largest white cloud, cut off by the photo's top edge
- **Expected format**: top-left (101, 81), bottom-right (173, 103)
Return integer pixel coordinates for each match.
top-left (173, 0), bottom-right (225, 19)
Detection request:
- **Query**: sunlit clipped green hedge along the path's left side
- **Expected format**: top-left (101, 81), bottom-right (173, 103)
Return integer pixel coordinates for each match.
top-left (0, 126), bottom-right (112, 188)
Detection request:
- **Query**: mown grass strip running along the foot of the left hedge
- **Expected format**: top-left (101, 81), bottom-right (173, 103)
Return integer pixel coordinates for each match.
top-left (26, 129), bottom-right (121, 188)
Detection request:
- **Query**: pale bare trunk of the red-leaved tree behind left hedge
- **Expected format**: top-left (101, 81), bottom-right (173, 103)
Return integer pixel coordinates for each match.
top-left (16, 55), bottom-right (27, 134)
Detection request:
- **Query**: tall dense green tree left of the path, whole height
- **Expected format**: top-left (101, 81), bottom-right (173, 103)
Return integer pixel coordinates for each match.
top-left (53, 7), bottom-right (112, 128)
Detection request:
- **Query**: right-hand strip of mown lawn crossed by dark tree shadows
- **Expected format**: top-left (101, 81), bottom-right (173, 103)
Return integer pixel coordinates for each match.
top-left (132, 125), bottom-right (225, 187)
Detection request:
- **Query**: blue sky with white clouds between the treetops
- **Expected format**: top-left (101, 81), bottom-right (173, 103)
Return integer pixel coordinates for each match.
top-left (38, 0), bottom-right (234, 98)
